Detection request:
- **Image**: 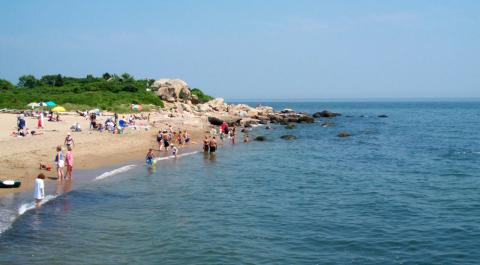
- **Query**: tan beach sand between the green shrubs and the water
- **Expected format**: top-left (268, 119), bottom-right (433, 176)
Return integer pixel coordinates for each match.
top-left (0, 113), bottom-right (210, 196)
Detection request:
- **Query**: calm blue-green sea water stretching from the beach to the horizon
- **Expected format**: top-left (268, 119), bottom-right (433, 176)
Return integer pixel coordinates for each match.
top-left (0, 102), bottom-right (480, 264)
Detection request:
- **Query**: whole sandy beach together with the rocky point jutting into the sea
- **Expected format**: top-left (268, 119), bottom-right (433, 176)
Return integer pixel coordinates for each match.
top-left (0, 98), bottom-right (315, 198)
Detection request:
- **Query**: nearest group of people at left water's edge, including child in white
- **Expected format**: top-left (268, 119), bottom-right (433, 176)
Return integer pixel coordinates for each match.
top-left (34, 133), bottom-right (75, 207)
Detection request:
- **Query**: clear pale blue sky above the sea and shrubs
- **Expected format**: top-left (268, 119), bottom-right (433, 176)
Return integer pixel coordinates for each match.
top-left (0, 0), bottom-right (480, 99)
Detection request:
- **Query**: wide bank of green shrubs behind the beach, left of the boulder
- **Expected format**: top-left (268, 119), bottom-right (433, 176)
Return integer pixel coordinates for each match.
top-left (0, 74), bottom-right (163, 111)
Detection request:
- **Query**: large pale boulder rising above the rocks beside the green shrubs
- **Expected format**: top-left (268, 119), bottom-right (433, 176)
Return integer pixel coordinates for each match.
top-left (151, 79), bottom-right (191, 102)
